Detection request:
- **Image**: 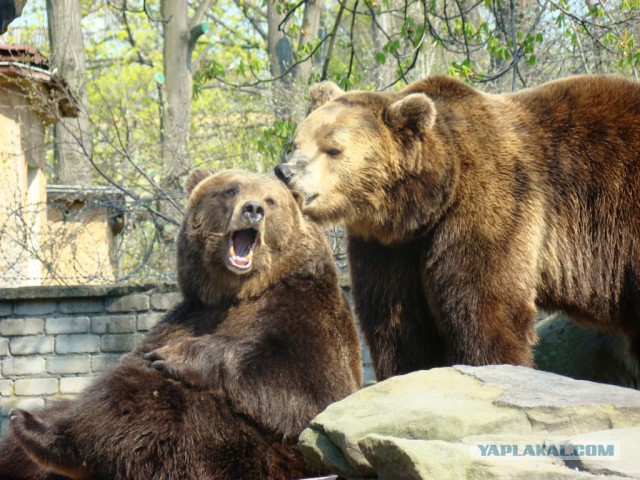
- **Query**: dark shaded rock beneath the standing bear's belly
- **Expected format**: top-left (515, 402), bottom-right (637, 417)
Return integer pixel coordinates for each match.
top-left (535, 313), bottom-right (640, 389)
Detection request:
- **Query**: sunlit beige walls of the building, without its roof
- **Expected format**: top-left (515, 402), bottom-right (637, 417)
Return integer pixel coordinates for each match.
top-left (0, 75), bottom-right (115, 288)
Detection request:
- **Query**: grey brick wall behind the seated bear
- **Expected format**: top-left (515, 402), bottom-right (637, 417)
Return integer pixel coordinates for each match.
top-left (0, 281), bottom-right (375, 433)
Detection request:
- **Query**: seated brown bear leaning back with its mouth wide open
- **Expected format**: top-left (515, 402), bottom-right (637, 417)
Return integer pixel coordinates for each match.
top-left (0, 171), bottom-right (361, 480)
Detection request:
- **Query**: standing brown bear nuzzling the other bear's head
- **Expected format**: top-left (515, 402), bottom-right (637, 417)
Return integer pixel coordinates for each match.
top-left (276, 76), bottom-right (640, 379)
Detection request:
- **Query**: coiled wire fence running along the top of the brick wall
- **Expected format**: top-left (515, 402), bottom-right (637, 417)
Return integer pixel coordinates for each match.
top-left (0, 195), bottom-right (347, 287)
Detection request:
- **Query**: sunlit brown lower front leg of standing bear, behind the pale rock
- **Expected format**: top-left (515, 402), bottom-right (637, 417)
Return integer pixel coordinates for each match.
top-left (424, 252), bottom-right (536, 367)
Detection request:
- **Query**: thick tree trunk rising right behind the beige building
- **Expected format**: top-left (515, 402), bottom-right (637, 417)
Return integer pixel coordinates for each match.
top-left (47, 0), bottom-right (93, 185)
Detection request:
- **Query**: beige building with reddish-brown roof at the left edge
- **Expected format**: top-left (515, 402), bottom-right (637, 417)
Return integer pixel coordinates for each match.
top-left (0, 46), bottom-right (120, 287)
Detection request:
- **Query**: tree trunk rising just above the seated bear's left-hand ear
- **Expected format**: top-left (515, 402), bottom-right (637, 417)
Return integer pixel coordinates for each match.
top-left (161, 0), bottom-right (193, 194)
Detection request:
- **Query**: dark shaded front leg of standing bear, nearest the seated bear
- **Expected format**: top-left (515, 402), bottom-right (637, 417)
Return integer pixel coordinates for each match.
top-left (348, 236), bottom-right (445, 380)
